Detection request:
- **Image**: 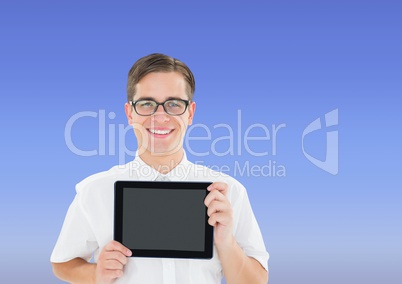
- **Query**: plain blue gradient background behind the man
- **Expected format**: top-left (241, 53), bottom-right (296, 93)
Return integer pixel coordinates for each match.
top-left (0, 0), bottom-right (402, 284)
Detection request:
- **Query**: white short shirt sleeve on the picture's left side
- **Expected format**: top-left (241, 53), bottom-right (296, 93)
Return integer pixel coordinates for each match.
top-left (50, 190), bottom-right (98, 263)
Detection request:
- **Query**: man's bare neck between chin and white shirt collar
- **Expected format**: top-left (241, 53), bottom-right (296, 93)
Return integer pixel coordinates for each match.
top-left (140, 149), bottom-right (184, 174)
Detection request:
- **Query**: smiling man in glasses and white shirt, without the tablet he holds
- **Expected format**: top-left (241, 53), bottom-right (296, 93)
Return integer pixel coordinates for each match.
top-left (51, 54), bottom-right (268, 284)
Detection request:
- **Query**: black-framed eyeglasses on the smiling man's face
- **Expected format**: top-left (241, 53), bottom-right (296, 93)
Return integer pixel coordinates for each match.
top-left (130, 99), bottom-right (190, 116)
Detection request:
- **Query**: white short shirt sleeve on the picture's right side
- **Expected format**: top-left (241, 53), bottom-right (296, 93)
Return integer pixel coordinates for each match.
top-left (232, 184), bottom-right (269, 271)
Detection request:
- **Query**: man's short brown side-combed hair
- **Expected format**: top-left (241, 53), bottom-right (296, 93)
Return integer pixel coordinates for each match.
top-left (127, 53), bottom-right (195, 101)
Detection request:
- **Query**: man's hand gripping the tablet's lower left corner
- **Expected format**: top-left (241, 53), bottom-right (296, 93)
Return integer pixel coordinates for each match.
top-left (95, 241), bottom-right (132, 284)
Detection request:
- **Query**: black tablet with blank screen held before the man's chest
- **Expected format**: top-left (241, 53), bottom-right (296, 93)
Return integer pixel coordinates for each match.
top-left (114, 181), bottom-right (213, 259)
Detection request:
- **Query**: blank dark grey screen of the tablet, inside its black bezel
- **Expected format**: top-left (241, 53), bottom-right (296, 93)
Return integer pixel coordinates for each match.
top-left (123, 188), bottom-right (205, 251)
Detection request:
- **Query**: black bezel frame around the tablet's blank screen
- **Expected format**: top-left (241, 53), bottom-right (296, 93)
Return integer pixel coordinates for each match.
top-left (113, 181), bottom-right (213, 259)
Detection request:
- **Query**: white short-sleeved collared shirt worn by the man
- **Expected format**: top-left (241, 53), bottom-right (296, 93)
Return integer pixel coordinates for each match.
top-left (50, 155), bottom-right (269, 284)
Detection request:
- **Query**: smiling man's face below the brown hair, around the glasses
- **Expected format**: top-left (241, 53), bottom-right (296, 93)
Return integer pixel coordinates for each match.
top-left (125, 72), bottom-right (195, 156)
